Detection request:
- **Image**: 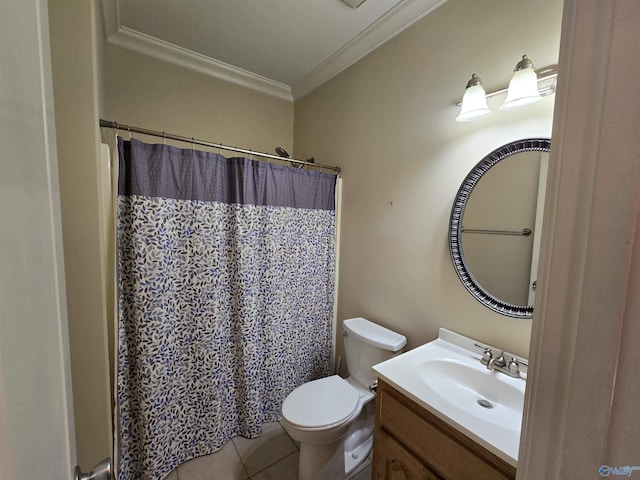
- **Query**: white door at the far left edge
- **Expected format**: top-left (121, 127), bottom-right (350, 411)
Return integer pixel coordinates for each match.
top-left (0, 0), bottom-right (76, 480)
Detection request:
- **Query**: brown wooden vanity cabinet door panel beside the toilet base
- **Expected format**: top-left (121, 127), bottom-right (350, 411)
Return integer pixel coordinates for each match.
top-left (373, 432), bottom-right (441, 480)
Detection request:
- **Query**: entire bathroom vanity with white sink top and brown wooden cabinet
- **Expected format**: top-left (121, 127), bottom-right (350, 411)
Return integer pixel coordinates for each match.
top-left (373, 329), bottom-right (526, 480)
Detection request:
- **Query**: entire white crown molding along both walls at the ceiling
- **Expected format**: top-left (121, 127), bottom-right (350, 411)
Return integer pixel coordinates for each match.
top-left (102, 0), bottom-right (447, 101)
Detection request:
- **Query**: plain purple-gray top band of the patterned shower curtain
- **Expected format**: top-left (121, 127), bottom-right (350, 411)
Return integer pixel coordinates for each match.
top-left (118, 137), bottom-right (336, 210)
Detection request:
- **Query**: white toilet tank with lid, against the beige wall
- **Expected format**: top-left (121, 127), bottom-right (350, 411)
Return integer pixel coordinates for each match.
top-left (342, 317), bottom-right (407, 388)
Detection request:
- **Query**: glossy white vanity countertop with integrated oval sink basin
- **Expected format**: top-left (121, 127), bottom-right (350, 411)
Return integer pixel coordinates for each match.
top-left (373, 329), bottom-right (526, 466)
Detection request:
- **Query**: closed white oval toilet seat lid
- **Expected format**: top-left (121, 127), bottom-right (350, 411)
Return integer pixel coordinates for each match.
top-left (282, 375), bottom-right (360, 428)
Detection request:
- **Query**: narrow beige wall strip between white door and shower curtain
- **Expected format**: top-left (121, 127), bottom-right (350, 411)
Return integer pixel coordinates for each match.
top-left (49, 0), bottom-right (112, 471)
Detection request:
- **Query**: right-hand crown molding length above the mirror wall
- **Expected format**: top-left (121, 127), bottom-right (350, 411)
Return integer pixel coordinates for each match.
top-left (292, 0), bottom-right (447, 100)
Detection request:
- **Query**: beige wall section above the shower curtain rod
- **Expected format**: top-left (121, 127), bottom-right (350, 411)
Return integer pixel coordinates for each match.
top-left (105, 45), bottom-right (293, 155)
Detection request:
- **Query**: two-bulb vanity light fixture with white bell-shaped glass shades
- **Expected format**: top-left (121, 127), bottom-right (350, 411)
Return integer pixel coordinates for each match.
top-left (456, 55), bottom-right (558, 122)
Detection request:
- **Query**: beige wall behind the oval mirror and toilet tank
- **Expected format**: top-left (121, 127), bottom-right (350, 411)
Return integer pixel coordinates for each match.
top-left (295, 0), bottom-right (562, 355)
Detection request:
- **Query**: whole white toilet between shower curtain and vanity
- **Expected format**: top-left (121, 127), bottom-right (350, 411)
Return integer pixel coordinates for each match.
top-left (282, 318), bottom-right (407, 480)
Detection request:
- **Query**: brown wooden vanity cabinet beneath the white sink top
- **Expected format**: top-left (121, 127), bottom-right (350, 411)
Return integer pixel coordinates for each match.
top-left (373, 380), bottom-right (516, 480)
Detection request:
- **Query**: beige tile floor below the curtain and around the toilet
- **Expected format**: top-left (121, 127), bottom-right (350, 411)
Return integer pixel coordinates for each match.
top-left (160, 422), bottom-right (371, 480)
